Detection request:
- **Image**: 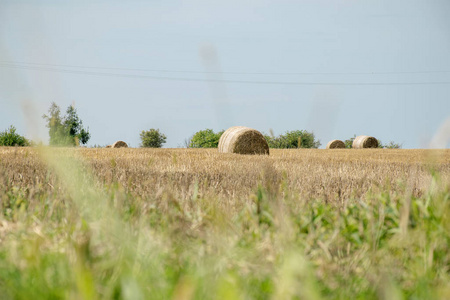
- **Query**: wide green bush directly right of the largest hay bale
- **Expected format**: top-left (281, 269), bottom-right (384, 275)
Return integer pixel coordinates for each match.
top-left (264, 130), bottom-right (321, 149)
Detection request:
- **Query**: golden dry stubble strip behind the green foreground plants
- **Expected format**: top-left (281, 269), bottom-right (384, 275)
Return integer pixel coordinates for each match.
top-left (0, 148), bottom-right (450, 206)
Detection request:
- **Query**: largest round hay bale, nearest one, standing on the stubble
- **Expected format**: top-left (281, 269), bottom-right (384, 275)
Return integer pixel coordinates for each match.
top-left (219, 126), bottom-right (269, 155)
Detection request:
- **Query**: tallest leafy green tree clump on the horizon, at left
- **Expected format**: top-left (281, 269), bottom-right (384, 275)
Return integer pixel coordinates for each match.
top-left (42, 102), bottom-right (91, 146)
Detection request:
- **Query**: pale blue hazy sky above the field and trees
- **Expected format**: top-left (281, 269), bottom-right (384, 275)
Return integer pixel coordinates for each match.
top-left (0, 0), bottom-right (450, 148)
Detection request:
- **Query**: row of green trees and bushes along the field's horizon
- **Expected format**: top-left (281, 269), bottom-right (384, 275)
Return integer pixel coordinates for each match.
top-left (0, 102), bottom-right (401, 149)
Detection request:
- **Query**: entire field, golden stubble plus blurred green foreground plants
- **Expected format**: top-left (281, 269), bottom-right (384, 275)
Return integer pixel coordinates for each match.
top-left (0, 147), bottom-right (450, 299)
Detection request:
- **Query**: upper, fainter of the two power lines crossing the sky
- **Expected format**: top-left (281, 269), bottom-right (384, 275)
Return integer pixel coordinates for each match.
top-left (0, 61), bottom-right (450, 75)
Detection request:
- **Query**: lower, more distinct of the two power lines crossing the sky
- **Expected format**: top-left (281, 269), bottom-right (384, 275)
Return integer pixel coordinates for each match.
top-left (0, 63), bottom-right (450, 86)
